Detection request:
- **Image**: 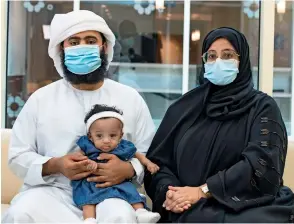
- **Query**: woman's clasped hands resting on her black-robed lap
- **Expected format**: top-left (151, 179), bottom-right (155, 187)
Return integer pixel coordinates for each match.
top-left (164, 186), bottom-right (206, 213)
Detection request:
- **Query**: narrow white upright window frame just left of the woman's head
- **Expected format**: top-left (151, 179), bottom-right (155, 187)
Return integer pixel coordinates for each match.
top-left (182, 0), bottom-right (191, 94)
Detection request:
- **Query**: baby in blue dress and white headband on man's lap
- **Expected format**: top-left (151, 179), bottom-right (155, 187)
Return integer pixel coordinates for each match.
top-left (72, 104), bottom-right (160, 223)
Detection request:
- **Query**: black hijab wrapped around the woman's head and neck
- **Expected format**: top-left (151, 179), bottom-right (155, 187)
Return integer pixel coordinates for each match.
top-left (200, 27), bottom-right (257, 120)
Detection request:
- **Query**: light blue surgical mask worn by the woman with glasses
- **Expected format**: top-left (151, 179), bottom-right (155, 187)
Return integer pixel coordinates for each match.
top-left (204, 58), bottom-right (239, 86)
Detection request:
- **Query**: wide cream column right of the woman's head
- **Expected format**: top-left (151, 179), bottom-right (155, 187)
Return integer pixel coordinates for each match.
top-left (259, 0), bottom-right (275, 96)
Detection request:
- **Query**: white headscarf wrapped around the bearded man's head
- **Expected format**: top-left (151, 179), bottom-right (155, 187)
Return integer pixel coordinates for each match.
top-left (48, 10), bottom-right (115, 77)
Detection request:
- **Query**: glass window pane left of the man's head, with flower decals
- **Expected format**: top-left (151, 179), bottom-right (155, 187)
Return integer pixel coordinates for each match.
top-left (5, 1), bottom-right (73, 128)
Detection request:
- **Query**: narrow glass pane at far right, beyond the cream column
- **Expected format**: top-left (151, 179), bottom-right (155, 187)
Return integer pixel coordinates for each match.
top-left (273, 0), bottom-right (294, 135)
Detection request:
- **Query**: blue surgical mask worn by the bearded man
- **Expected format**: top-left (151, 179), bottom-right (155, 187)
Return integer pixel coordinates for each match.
top-left (64, 45), bottom-right (101, 75)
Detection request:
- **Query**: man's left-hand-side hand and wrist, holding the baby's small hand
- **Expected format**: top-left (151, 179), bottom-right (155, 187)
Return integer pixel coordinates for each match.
top-left (42, 152), bottom-right (92, 180)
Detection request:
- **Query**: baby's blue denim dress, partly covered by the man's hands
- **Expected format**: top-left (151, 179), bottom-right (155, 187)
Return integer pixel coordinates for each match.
top-left (71, 136), bottom-right (145, 208)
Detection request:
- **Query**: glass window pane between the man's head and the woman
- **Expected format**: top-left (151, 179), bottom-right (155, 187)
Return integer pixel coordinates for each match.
top-left (80, 1), bottom-right (184, 129)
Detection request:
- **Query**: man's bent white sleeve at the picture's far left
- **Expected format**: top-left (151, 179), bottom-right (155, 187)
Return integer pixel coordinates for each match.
top-left (8, 94), bottom-right (56, 186)
